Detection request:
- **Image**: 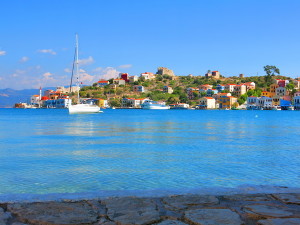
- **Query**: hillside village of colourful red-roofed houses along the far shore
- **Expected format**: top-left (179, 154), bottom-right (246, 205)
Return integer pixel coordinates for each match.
top-left (15, 66), bottom-right (300, 110)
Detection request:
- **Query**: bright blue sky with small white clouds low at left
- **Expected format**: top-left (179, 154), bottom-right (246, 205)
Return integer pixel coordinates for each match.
top-left (0, 0), bottom-right (300, 90)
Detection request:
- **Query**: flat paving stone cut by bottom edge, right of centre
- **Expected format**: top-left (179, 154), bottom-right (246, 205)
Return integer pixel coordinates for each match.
top-left (184, 209), bottom-right (243, 225)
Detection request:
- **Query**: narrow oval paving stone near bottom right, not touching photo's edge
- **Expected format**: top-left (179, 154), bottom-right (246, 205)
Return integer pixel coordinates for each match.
top-left (243, 205), bottom-right (293, 218)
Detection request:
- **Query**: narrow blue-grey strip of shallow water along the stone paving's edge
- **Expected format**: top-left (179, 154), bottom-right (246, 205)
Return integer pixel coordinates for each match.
top-left (0, 184), bottom-right (300, 204)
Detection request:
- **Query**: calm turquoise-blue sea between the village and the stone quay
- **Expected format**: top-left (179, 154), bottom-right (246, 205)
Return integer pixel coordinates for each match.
top-left (0, 109), bottom-right (300, 195)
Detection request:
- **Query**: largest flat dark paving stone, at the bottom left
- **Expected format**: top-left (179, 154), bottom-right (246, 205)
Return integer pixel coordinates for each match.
top-left (8, 202), bottom-right (98, 225)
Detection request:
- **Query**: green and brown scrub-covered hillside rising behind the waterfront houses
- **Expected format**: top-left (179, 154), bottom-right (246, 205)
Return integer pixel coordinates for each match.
top-left (80, 75), bottom-right (292, 106)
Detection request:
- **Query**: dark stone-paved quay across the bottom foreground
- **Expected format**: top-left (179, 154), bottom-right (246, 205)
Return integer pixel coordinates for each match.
top-left (0, 193), bottom-right (300, 225)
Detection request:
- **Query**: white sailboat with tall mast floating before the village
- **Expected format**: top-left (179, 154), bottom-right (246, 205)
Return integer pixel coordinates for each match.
top-left (68, 34), bottom-right (102, 114)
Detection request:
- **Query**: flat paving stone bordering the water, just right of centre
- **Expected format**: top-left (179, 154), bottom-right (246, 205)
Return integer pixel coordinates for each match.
top-left (163, 195), bottom-right (219, 210)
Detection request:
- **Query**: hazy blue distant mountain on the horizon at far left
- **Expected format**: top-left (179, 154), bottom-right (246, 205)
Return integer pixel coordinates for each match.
top-left (0, 87), bottom-right (56, 108)
